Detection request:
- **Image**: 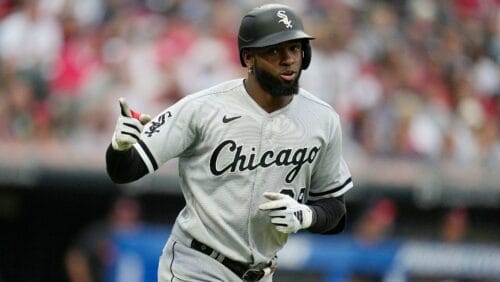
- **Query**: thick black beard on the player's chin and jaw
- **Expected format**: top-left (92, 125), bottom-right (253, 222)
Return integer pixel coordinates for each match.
top-left (254, 66), bottom-right (302, 97)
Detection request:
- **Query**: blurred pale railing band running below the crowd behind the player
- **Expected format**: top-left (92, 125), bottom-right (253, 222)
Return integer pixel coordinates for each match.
top-left (0, 142), bottom-right (500, 207)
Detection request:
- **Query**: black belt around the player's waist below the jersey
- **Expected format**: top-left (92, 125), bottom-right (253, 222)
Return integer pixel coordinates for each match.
top-left (191, 239), bottom-right (272, 282)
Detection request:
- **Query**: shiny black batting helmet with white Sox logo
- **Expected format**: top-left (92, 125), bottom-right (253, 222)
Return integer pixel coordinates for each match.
top-left (238, 4), bottom-right (314, 69)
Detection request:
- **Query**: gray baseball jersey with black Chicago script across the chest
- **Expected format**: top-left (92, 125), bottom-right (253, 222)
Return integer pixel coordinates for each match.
top-left (134, 79), bottom-right (352, 263)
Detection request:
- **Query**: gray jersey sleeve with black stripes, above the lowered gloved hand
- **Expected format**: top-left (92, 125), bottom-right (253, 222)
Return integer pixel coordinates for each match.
top-left (308, 115), bottom-right (353, 202)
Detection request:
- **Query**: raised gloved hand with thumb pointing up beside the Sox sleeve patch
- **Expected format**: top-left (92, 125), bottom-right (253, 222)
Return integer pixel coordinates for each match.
top-left (111, 97), bottom-right (151, 151)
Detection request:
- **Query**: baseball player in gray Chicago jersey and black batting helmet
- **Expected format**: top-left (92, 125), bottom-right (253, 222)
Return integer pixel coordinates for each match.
top-left (106, 4), bottom-right (353, 281)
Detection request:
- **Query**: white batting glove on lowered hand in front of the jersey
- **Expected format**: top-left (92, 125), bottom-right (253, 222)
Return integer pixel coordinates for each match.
top-left (259, 192), bottom-right (313, 233)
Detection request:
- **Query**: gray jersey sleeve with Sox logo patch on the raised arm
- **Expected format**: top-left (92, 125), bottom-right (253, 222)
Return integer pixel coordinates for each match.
top-left (134, 96), bottom-right (196, 173)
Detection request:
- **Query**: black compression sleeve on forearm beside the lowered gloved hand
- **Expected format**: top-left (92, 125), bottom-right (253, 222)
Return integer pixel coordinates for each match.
top-left (308, 196), bottom-right (346, 234)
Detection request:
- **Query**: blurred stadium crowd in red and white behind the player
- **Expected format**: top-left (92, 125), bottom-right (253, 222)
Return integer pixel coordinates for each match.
top-left (0, 0), bottom-right (500, 166)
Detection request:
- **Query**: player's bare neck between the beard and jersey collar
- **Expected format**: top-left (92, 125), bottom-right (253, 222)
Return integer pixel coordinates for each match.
top-left (243, 78), bottom-right (293, 113)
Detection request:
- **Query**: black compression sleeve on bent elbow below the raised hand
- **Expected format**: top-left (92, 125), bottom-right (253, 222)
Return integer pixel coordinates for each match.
top-left (106, 144), bottom-right (148, 183)
